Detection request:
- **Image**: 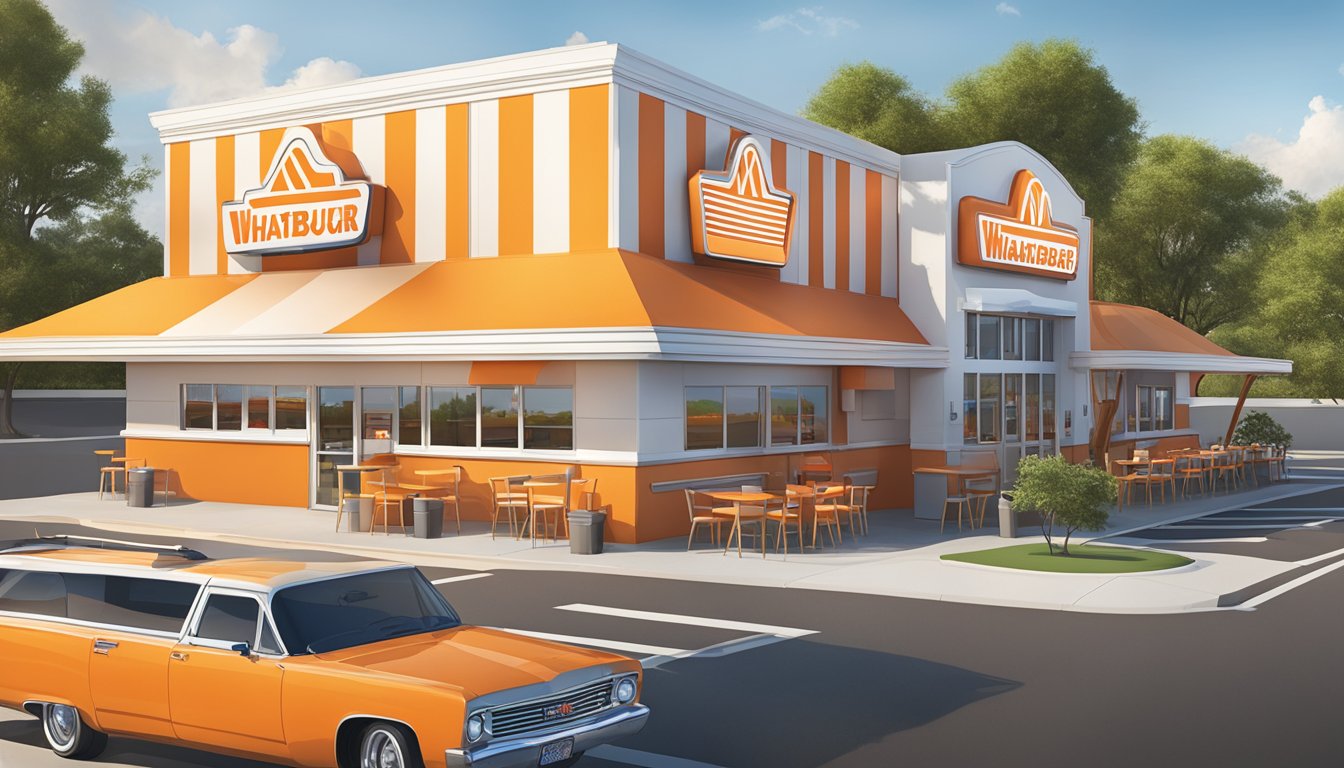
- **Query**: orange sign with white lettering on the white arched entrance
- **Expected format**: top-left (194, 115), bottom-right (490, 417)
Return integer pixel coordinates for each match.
top-left (957, 169), bottom-right (1078, 280)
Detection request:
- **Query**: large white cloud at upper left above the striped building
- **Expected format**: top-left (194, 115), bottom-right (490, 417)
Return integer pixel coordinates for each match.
top-left (47, 0), bottom-right (359, 106)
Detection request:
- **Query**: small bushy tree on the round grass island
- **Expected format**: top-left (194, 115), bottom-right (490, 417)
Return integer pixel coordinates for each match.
top-left (1012, 456), bottom-right (1116, 557)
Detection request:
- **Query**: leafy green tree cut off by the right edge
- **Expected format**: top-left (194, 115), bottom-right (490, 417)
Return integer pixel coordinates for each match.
top-left (1199, 187), bottom-right (1344, 398)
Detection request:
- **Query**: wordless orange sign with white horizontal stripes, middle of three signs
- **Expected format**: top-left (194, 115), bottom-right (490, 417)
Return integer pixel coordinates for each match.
top-left (689, 136), bottom-right (793, 266)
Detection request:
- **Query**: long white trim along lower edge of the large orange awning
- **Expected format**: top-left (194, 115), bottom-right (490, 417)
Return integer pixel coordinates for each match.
top-left (0, 327), bottom-right (948, 369)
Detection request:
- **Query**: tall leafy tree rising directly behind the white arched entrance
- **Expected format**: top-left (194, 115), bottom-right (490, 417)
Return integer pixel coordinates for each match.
top-left (939, 39), bottom-right (1144, 219)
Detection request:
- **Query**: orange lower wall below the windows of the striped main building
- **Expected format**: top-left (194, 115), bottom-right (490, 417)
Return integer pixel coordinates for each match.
top-left (126, 438), bottom-right (914, 543)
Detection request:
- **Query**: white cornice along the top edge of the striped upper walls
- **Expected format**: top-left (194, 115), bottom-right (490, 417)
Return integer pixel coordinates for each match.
top-left (149, 43), bottom-right (900, 175)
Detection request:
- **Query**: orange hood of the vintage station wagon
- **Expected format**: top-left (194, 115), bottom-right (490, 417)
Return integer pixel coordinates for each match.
top-left (317, 627), bottom-right (640, 697)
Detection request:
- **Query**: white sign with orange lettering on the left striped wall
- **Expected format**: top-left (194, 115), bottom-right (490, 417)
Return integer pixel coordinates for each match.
top-left (223, 128), bottom-right (382, 256)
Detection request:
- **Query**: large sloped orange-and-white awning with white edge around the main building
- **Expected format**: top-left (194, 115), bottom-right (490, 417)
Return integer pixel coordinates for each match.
top-left (0, 249), bottom-right (948, 365)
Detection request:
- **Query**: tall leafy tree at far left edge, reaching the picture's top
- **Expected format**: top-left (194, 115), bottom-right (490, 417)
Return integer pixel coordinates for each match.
top-left (0, 0), bottom-right (153, 437)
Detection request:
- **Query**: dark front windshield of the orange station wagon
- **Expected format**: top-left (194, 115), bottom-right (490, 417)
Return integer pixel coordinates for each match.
top-left (270, 568), bottom-right (461, 654)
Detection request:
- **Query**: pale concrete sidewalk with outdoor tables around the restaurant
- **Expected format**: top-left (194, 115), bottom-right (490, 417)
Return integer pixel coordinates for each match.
top-left (0, 479), bottom-right (1344, 613)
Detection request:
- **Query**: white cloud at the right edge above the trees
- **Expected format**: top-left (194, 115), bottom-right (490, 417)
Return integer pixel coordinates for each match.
top-left (1238, 95), bottom-right (1344, 198)
